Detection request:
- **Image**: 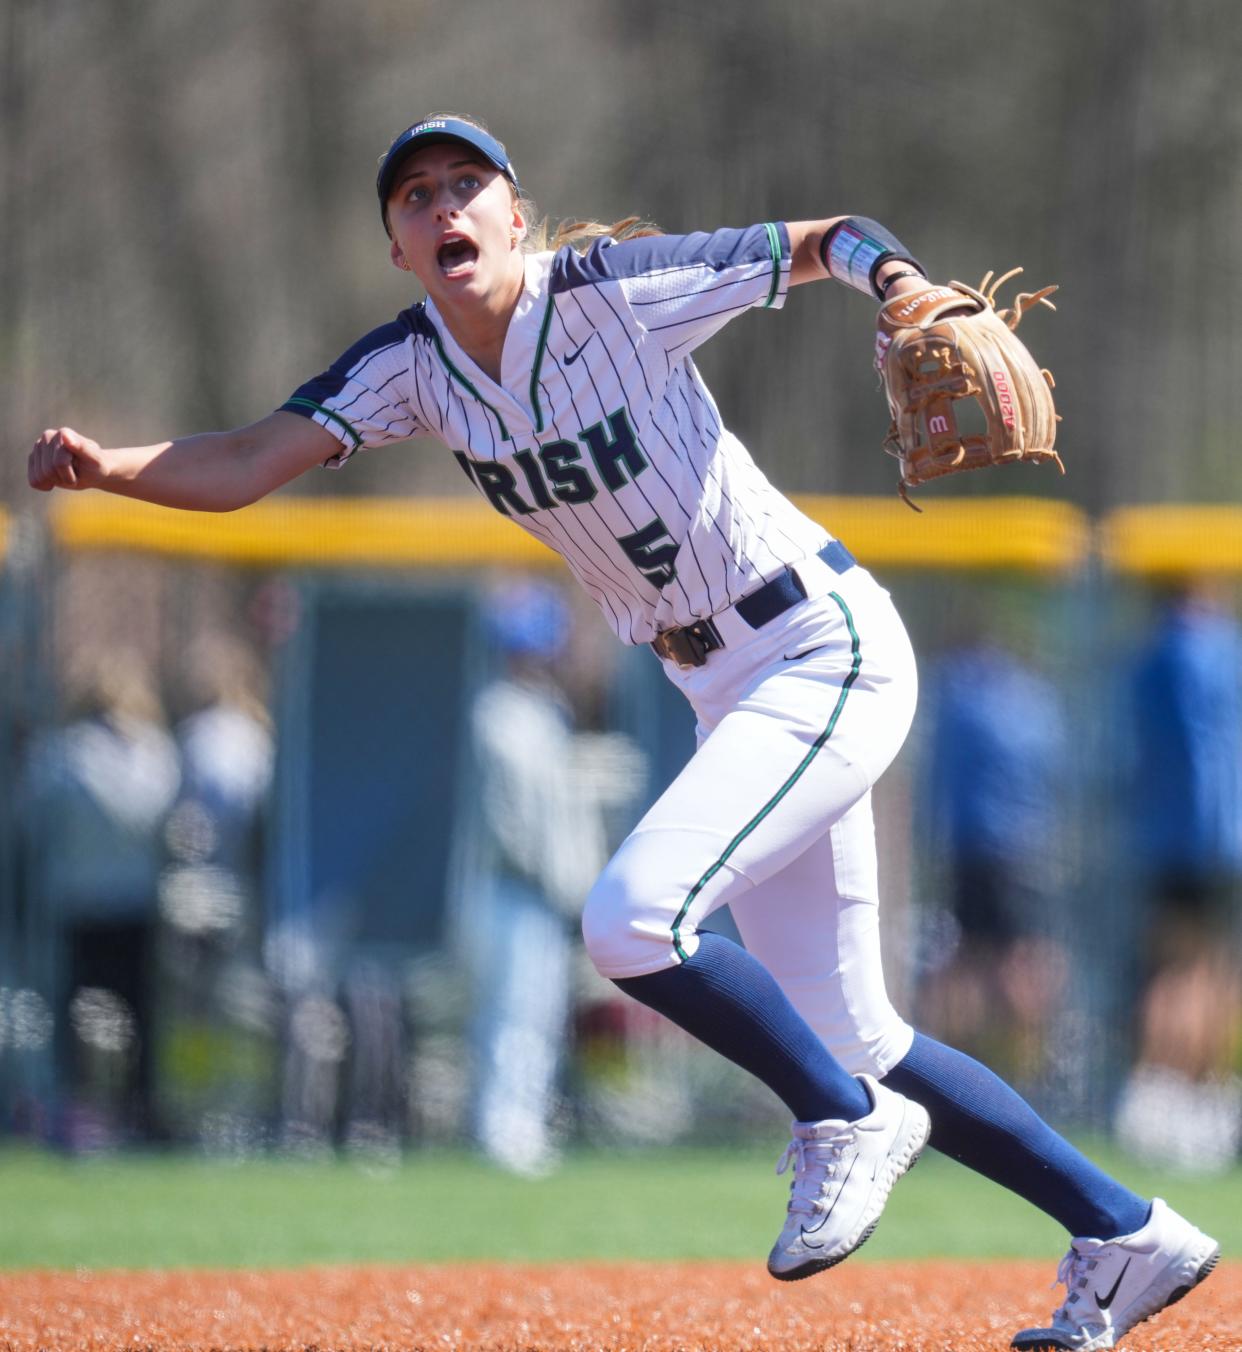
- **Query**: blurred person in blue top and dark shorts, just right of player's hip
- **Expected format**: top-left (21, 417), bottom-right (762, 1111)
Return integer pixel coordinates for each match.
top-left (922, 631), bottom-right (1066, 1090)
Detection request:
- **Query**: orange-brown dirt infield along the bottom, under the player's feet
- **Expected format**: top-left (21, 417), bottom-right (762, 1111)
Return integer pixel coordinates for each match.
top-left (0, 1261), bottom-right (1242, 1352)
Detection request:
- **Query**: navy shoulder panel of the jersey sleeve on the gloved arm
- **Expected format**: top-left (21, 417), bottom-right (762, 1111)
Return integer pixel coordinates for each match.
top-left (549, 226), bottom-right (788, 295)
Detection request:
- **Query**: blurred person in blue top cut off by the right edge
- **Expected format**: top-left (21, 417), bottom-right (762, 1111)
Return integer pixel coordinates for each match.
top-left (1118, 579), bottom-right (1242, 1169)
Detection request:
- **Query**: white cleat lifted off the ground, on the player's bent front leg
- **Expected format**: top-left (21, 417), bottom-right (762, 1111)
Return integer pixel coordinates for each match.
top-left (768, 1075), bottom-right (931, 1282)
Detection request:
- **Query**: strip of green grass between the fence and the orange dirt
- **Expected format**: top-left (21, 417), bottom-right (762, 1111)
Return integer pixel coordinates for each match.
top-left (0, 1145), bottom-right (1242, 1268)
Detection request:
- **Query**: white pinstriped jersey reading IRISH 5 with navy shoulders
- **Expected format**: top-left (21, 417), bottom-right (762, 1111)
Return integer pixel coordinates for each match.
top-left (282, 224), bottom-right (828, 644)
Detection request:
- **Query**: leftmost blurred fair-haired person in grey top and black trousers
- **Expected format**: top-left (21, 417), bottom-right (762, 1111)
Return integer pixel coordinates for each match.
top-left (22, 650), bottom-right (180, 1148)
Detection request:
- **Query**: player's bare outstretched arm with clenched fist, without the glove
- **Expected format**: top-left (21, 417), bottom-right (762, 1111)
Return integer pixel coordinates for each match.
top-left (27, 412), bottom-right (341, 511)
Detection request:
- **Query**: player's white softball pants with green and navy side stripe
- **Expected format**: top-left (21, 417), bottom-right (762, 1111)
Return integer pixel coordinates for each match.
top-left (582, 560), bottom-right (918, 1076)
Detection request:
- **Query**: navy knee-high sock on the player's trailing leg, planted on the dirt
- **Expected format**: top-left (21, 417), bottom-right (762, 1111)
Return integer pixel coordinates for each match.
top-left (884, 1033), bottom-right (1150, 1240)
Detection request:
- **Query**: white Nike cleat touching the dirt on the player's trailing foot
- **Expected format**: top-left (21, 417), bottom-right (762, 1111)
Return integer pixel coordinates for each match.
top-left (1012, 1198), bottom-right (1220, 1352)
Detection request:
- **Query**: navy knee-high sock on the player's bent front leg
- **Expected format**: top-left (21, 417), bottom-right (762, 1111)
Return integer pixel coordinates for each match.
top-left (615, 933), bottom-right (872, 1122)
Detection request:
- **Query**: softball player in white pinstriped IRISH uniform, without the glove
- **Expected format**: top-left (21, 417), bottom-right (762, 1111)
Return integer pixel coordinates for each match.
top-left (30, 114), bottom-right (1218, 1348)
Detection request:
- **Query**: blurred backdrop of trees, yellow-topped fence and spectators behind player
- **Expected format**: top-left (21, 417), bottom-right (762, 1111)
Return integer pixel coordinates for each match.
top-left (0, 0), bottom-right (1242, 1174)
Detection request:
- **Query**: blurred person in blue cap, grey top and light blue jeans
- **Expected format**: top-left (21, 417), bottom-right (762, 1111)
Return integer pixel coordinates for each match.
top-left (464, 580), bottom-right (607, 1174)
